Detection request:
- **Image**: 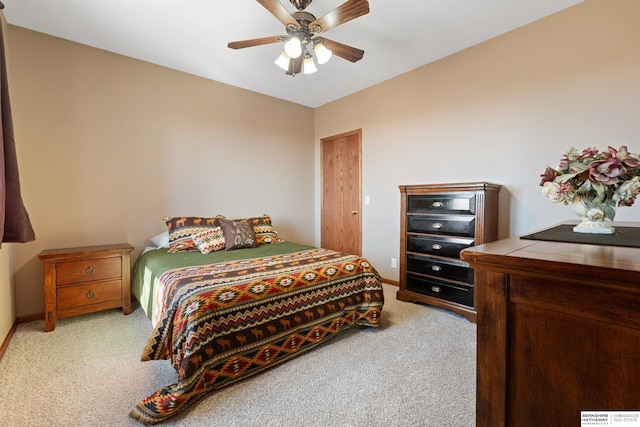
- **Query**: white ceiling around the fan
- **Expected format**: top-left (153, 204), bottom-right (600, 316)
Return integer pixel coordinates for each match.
top-left (3, 0), bottom-right (583, 108)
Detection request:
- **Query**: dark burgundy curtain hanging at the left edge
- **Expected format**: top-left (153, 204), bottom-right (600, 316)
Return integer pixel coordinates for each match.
top-left (0, 12), bottom-right (36, 247)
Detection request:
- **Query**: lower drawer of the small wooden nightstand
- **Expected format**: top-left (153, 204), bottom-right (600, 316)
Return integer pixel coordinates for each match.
top-left (56, 280), bottom-right (122, 310)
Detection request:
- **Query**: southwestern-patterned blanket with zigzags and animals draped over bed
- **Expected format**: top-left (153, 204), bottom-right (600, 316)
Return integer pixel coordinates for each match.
top-left (130, 249), bottom-right (384, 424)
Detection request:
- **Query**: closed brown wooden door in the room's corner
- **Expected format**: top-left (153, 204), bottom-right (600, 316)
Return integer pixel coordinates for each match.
top-left (320, 129), bottom-right (362, 256)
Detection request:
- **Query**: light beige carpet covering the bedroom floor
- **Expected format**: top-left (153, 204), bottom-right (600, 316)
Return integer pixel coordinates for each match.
top-left (0, 285), bottom-right (476, 427)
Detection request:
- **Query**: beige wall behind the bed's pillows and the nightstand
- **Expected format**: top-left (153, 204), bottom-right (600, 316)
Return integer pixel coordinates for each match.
top-left (5, 26), bottom-right (314, 317)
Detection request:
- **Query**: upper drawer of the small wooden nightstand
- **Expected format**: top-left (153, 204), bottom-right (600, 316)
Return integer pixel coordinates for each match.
top-left (56, 256), bottom-right (122, 285)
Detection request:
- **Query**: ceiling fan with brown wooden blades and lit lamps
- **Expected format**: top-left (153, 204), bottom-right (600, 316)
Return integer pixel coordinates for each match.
top-left (227, 0), bottom-right (369, 76)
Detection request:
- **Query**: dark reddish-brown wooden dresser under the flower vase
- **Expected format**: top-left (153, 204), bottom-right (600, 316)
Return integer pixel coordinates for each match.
top-left (461, 223), bottom-right (640, 427)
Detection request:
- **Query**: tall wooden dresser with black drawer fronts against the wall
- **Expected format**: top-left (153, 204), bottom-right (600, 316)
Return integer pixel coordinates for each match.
top-left (397, 182), bottom-right (500, 322)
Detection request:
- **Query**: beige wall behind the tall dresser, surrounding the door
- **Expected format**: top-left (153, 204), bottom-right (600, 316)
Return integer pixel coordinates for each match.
top-left (315, 0), bottom-right (640, 279)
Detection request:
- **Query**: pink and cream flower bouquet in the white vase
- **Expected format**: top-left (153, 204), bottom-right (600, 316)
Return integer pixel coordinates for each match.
top-left (540, 146), bottom-right (640, 220)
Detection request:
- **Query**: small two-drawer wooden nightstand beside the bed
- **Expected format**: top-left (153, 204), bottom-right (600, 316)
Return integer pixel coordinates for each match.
top-left (38, 244), bottom-right (133, 332)
